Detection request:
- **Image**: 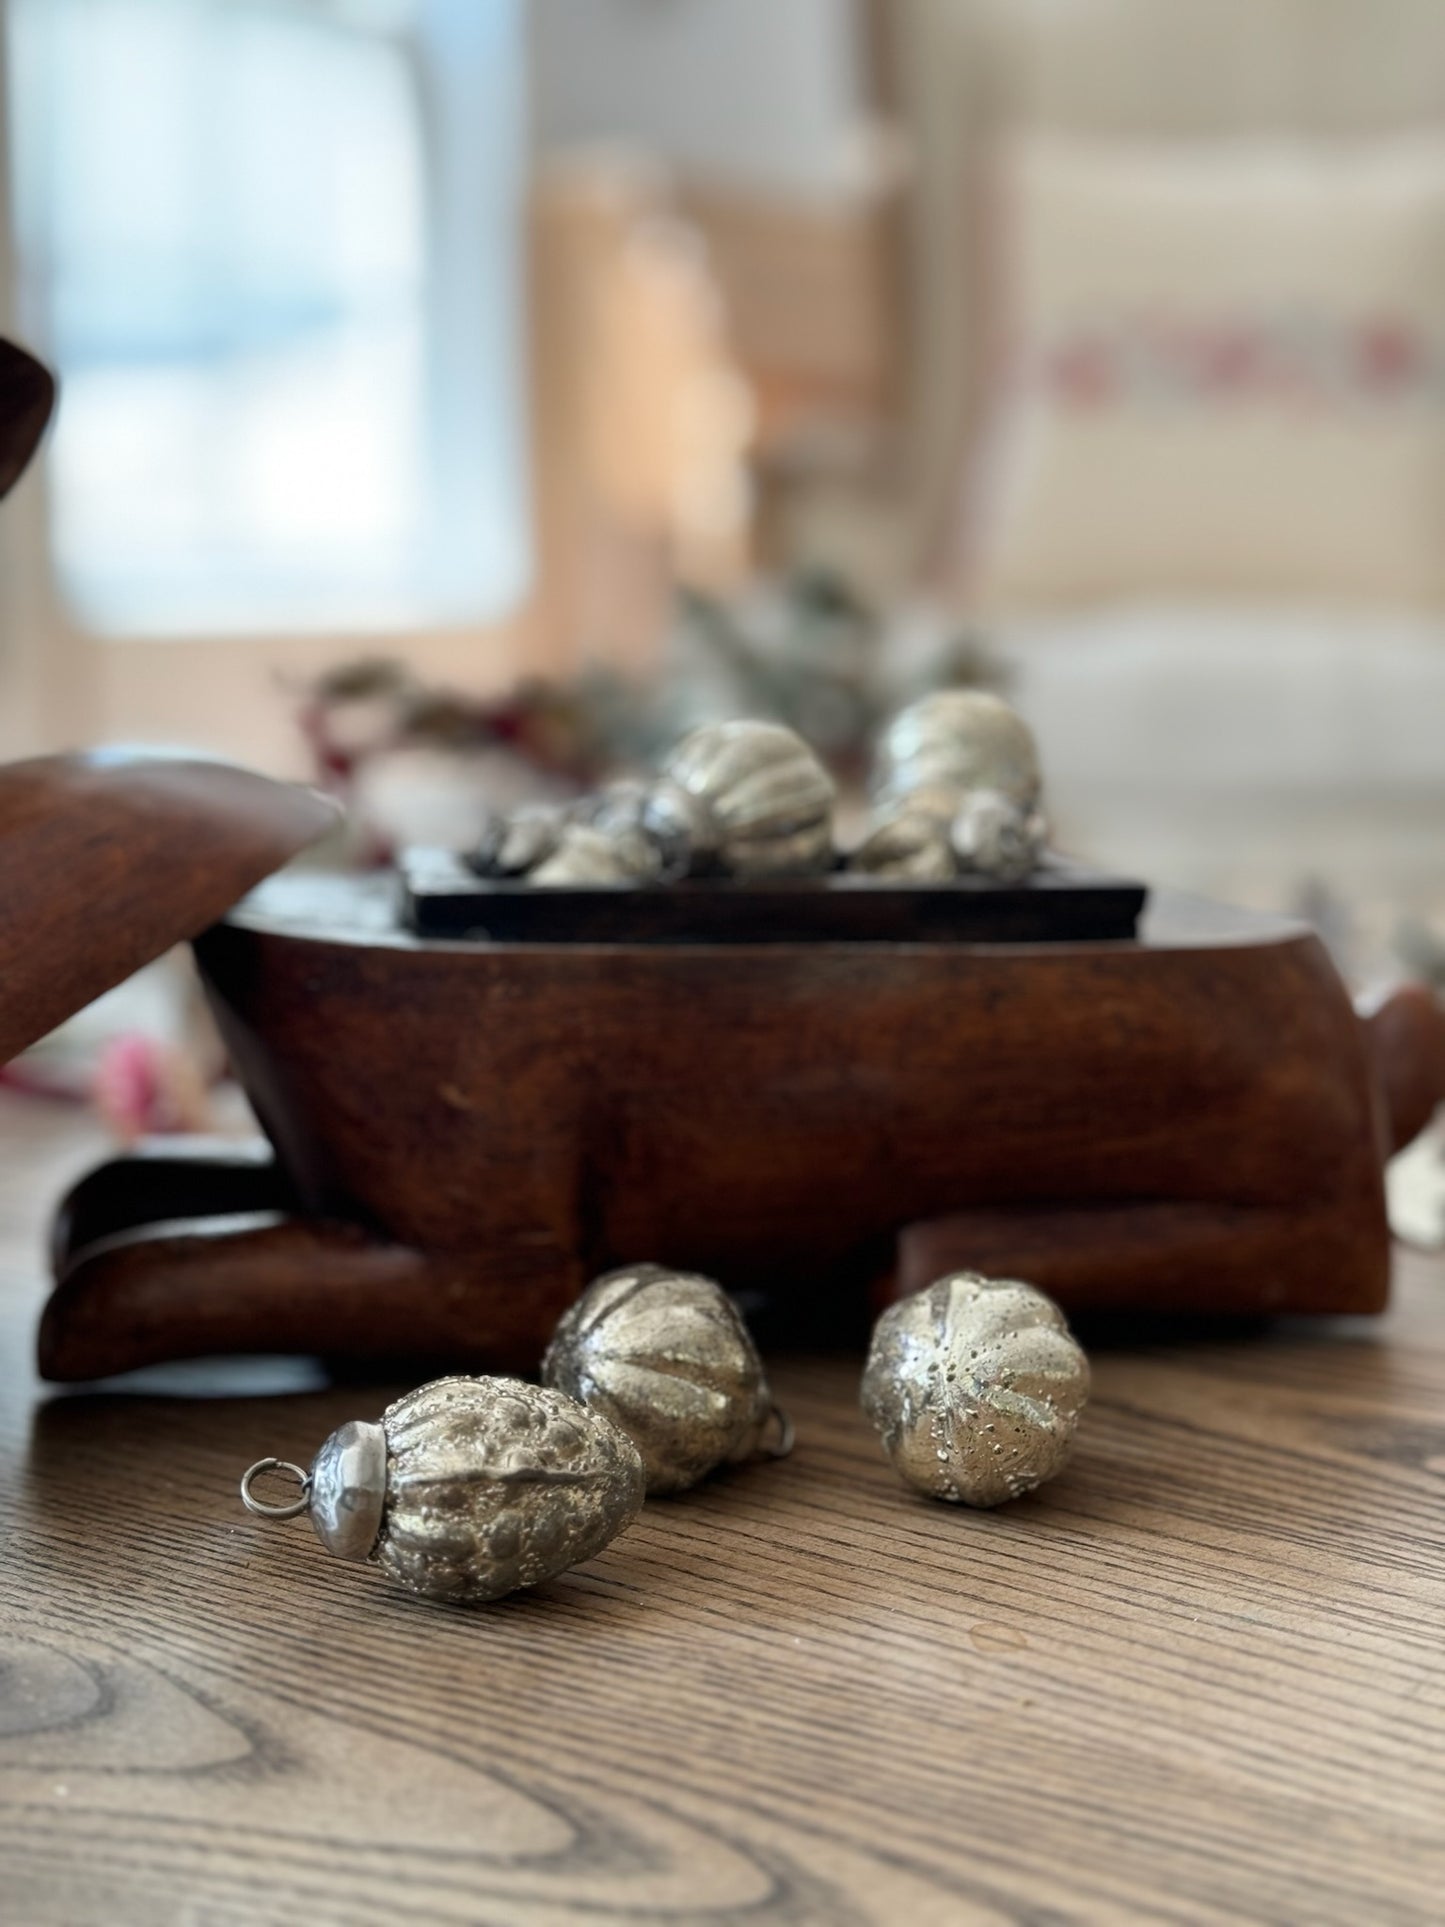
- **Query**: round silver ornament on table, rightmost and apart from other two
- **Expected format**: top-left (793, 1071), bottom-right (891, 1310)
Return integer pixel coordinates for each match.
top-left (863, 1272), bottom-right (1089, 1505)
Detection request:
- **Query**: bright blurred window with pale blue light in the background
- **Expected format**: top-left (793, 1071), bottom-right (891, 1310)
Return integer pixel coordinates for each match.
top-left (10, 0), bottom-right (530, 634)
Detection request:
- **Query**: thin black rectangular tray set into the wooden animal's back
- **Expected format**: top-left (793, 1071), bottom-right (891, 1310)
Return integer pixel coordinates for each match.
top-left (401, 850), bottom-right (1146, 944)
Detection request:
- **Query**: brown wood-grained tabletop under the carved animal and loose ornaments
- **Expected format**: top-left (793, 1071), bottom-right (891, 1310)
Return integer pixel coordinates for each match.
top-left (0, 1100), bottom-right (1445, 1927)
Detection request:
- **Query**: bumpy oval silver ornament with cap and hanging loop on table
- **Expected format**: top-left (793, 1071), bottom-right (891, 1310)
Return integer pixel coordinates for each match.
top-left (241, 1378), bottom-right (645, 1605)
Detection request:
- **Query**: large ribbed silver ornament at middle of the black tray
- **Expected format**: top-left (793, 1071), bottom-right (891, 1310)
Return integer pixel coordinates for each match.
top-left (645, 721), bottom-right (836, 877)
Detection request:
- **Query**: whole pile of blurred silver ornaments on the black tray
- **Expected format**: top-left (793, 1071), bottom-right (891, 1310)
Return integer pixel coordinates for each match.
top-left (468, 690), bottom-right (1048, 888)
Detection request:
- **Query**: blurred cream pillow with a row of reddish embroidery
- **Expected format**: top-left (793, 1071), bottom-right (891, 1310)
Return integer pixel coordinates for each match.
top-left (975, 133), bottom-right (1445, 611)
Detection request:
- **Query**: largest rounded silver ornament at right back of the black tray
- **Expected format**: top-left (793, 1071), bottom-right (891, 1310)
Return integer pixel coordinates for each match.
top-left (875, 690), bottom-right (1042, 821)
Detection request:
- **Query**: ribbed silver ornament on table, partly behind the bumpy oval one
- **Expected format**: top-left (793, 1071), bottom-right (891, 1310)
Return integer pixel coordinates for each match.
top-left (541, 1264), bottom-right (792, 1493)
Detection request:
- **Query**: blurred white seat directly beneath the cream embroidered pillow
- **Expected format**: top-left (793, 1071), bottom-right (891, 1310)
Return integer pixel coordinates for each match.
top-left (1010, 603), bottom-right (1445, 909)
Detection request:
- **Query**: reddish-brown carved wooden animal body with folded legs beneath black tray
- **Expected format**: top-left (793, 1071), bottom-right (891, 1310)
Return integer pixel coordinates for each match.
top-left (40, 877), bottom-right (1441, 1378)
